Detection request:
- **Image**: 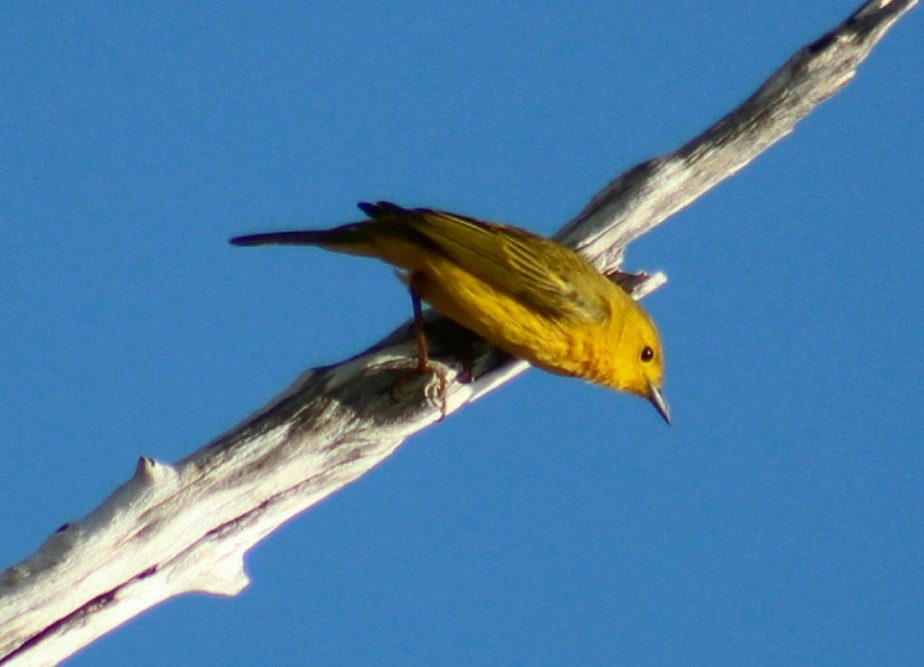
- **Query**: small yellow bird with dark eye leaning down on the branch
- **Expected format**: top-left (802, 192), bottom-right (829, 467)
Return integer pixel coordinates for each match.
top-left (231, 202), bottom-right (670, 423)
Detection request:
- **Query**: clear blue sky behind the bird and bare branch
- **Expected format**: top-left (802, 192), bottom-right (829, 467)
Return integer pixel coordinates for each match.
top-left (0, 0), bottom-right (924, 666)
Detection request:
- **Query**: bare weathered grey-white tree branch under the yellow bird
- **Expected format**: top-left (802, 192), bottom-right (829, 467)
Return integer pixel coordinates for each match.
top-left (0, 0), bottom-right (917, 665)
